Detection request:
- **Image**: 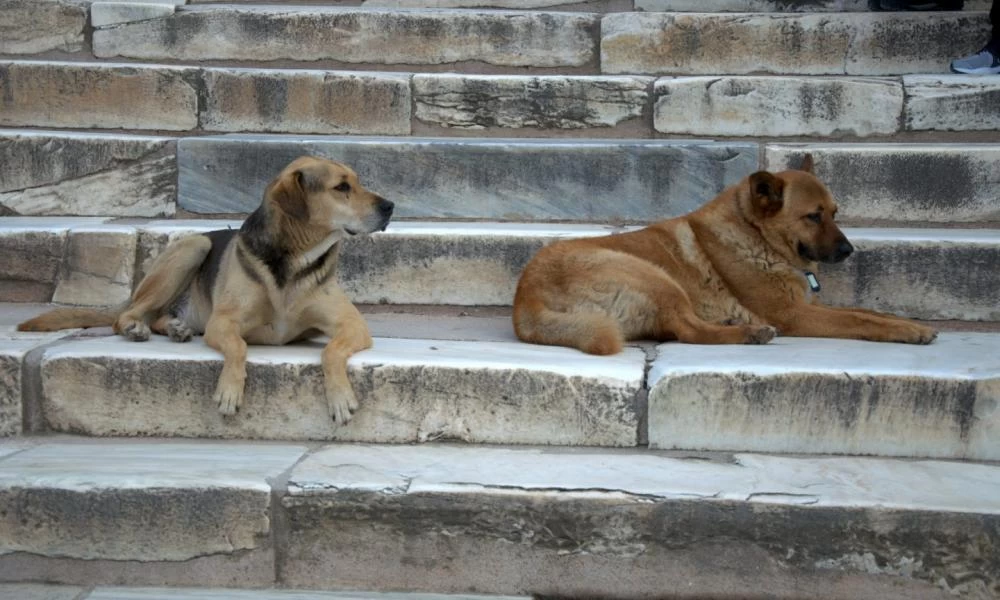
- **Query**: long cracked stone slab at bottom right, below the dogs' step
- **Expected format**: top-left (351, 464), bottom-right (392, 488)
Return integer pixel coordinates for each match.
top-left (279, 446), bottom-right (1000, 600)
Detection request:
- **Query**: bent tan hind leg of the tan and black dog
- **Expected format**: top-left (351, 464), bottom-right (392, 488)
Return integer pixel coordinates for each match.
top-left (114, 235), bottom-right (212, 342)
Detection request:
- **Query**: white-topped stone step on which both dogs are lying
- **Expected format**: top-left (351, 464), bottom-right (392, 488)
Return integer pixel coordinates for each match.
top-left (0, 305), bottom-right (1000, 461)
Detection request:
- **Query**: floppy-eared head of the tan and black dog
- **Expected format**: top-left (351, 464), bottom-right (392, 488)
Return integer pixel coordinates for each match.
top-left (264, 156), bottom-right (393, 235)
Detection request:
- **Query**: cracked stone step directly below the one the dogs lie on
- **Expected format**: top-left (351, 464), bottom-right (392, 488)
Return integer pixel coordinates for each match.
top-left (0, 438), bottom-right (1000, 600)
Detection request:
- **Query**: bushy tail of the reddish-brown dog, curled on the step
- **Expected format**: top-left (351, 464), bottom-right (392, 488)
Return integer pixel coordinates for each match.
top-left (514, 294), bottom-right (625, 356)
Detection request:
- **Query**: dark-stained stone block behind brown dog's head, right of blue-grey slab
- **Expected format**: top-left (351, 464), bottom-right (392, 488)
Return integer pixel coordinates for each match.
top-left (764, 144), bottom-right (1000, 223)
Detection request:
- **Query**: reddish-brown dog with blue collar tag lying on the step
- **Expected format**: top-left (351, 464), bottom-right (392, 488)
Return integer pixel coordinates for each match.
top-left (514, 156), bottom-right (937, 354)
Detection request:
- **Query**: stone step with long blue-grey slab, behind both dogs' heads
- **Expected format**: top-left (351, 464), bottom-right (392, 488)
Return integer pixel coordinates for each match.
top-left (0, 129), bottom-right (1000, 226)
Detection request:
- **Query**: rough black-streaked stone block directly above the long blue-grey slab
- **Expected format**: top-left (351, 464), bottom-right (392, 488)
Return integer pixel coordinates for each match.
top-left (413, 74), bottom-right (653, 129)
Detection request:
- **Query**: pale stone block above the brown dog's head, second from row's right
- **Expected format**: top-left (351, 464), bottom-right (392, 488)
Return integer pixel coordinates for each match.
top-left (653, 76), bottom-right (903, 137)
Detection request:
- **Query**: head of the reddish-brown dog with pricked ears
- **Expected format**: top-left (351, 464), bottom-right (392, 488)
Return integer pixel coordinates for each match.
top-left (746, 154), bottom-right (854, 265)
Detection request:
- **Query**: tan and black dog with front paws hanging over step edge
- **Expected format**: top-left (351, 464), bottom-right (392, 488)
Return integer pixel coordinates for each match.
top-left (18, 157), bottom-right (393, 424)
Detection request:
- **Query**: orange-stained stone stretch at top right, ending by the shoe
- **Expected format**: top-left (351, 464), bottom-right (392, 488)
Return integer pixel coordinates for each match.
top-left (601, 11), bottom-right (989, 75)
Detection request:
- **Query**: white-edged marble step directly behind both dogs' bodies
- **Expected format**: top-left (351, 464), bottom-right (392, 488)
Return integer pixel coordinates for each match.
top-left (0, 217), bottom-right (1000, 321)
